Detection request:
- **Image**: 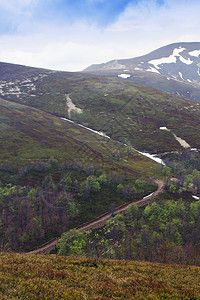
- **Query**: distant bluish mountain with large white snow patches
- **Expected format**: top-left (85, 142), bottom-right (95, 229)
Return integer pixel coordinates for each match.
top-left (84, 42), bottom-right (200, 100)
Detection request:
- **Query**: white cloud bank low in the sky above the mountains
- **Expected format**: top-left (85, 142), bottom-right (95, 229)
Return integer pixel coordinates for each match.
top-left (0, 0), bottom-right (200, 71)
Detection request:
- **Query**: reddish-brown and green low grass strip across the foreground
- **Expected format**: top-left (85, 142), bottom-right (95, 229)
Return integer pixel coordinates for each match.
top-left (0, 253), bottom-right (200, 299)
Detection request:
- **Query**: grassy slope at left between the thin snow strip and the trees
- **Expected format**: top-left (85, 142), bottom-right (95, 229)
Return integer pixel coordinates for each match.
top-left (0, 99), bottom-right (159, 176)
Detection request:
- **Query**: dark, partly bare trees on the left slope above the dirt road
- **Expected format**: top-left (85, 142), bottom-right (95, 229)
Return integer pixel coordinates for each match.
top-left (0, 159), bottom-right (155, 251)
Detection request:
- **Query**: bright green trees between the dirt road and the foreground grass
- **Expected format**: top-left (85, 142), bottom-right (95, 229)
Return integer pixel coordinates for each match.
top-left (58, 200), bottom-right (200, 265)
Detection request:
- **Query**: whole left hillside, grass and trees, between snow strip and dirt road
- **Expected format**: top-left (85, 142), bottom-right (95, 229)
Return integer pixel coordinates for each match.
top-left (0, 99), bottom-right (161, 250)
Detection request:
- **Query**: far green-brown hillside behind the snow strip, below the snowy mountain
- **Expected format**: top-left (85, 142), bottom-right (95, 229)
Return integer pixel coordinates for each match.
top-left (4, 67), bottom-right (200, 152)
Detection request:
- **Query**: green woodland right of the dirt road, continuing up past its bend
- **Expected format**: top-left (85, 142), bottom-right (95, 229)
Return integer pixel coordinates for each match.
top-left (58, 151), bottom-right (200, 265)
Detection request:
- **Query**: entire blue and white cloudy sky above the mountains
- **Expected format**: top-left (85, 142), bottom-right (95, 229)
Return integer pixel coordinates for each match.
top-left (0, 0), bottom-right (200, 71)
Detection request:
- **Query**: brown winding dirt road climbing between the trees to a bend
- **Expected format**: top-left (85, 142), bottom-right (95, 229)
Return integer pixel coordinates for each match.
top-left (27, 180), bottom-right (164, 254)
